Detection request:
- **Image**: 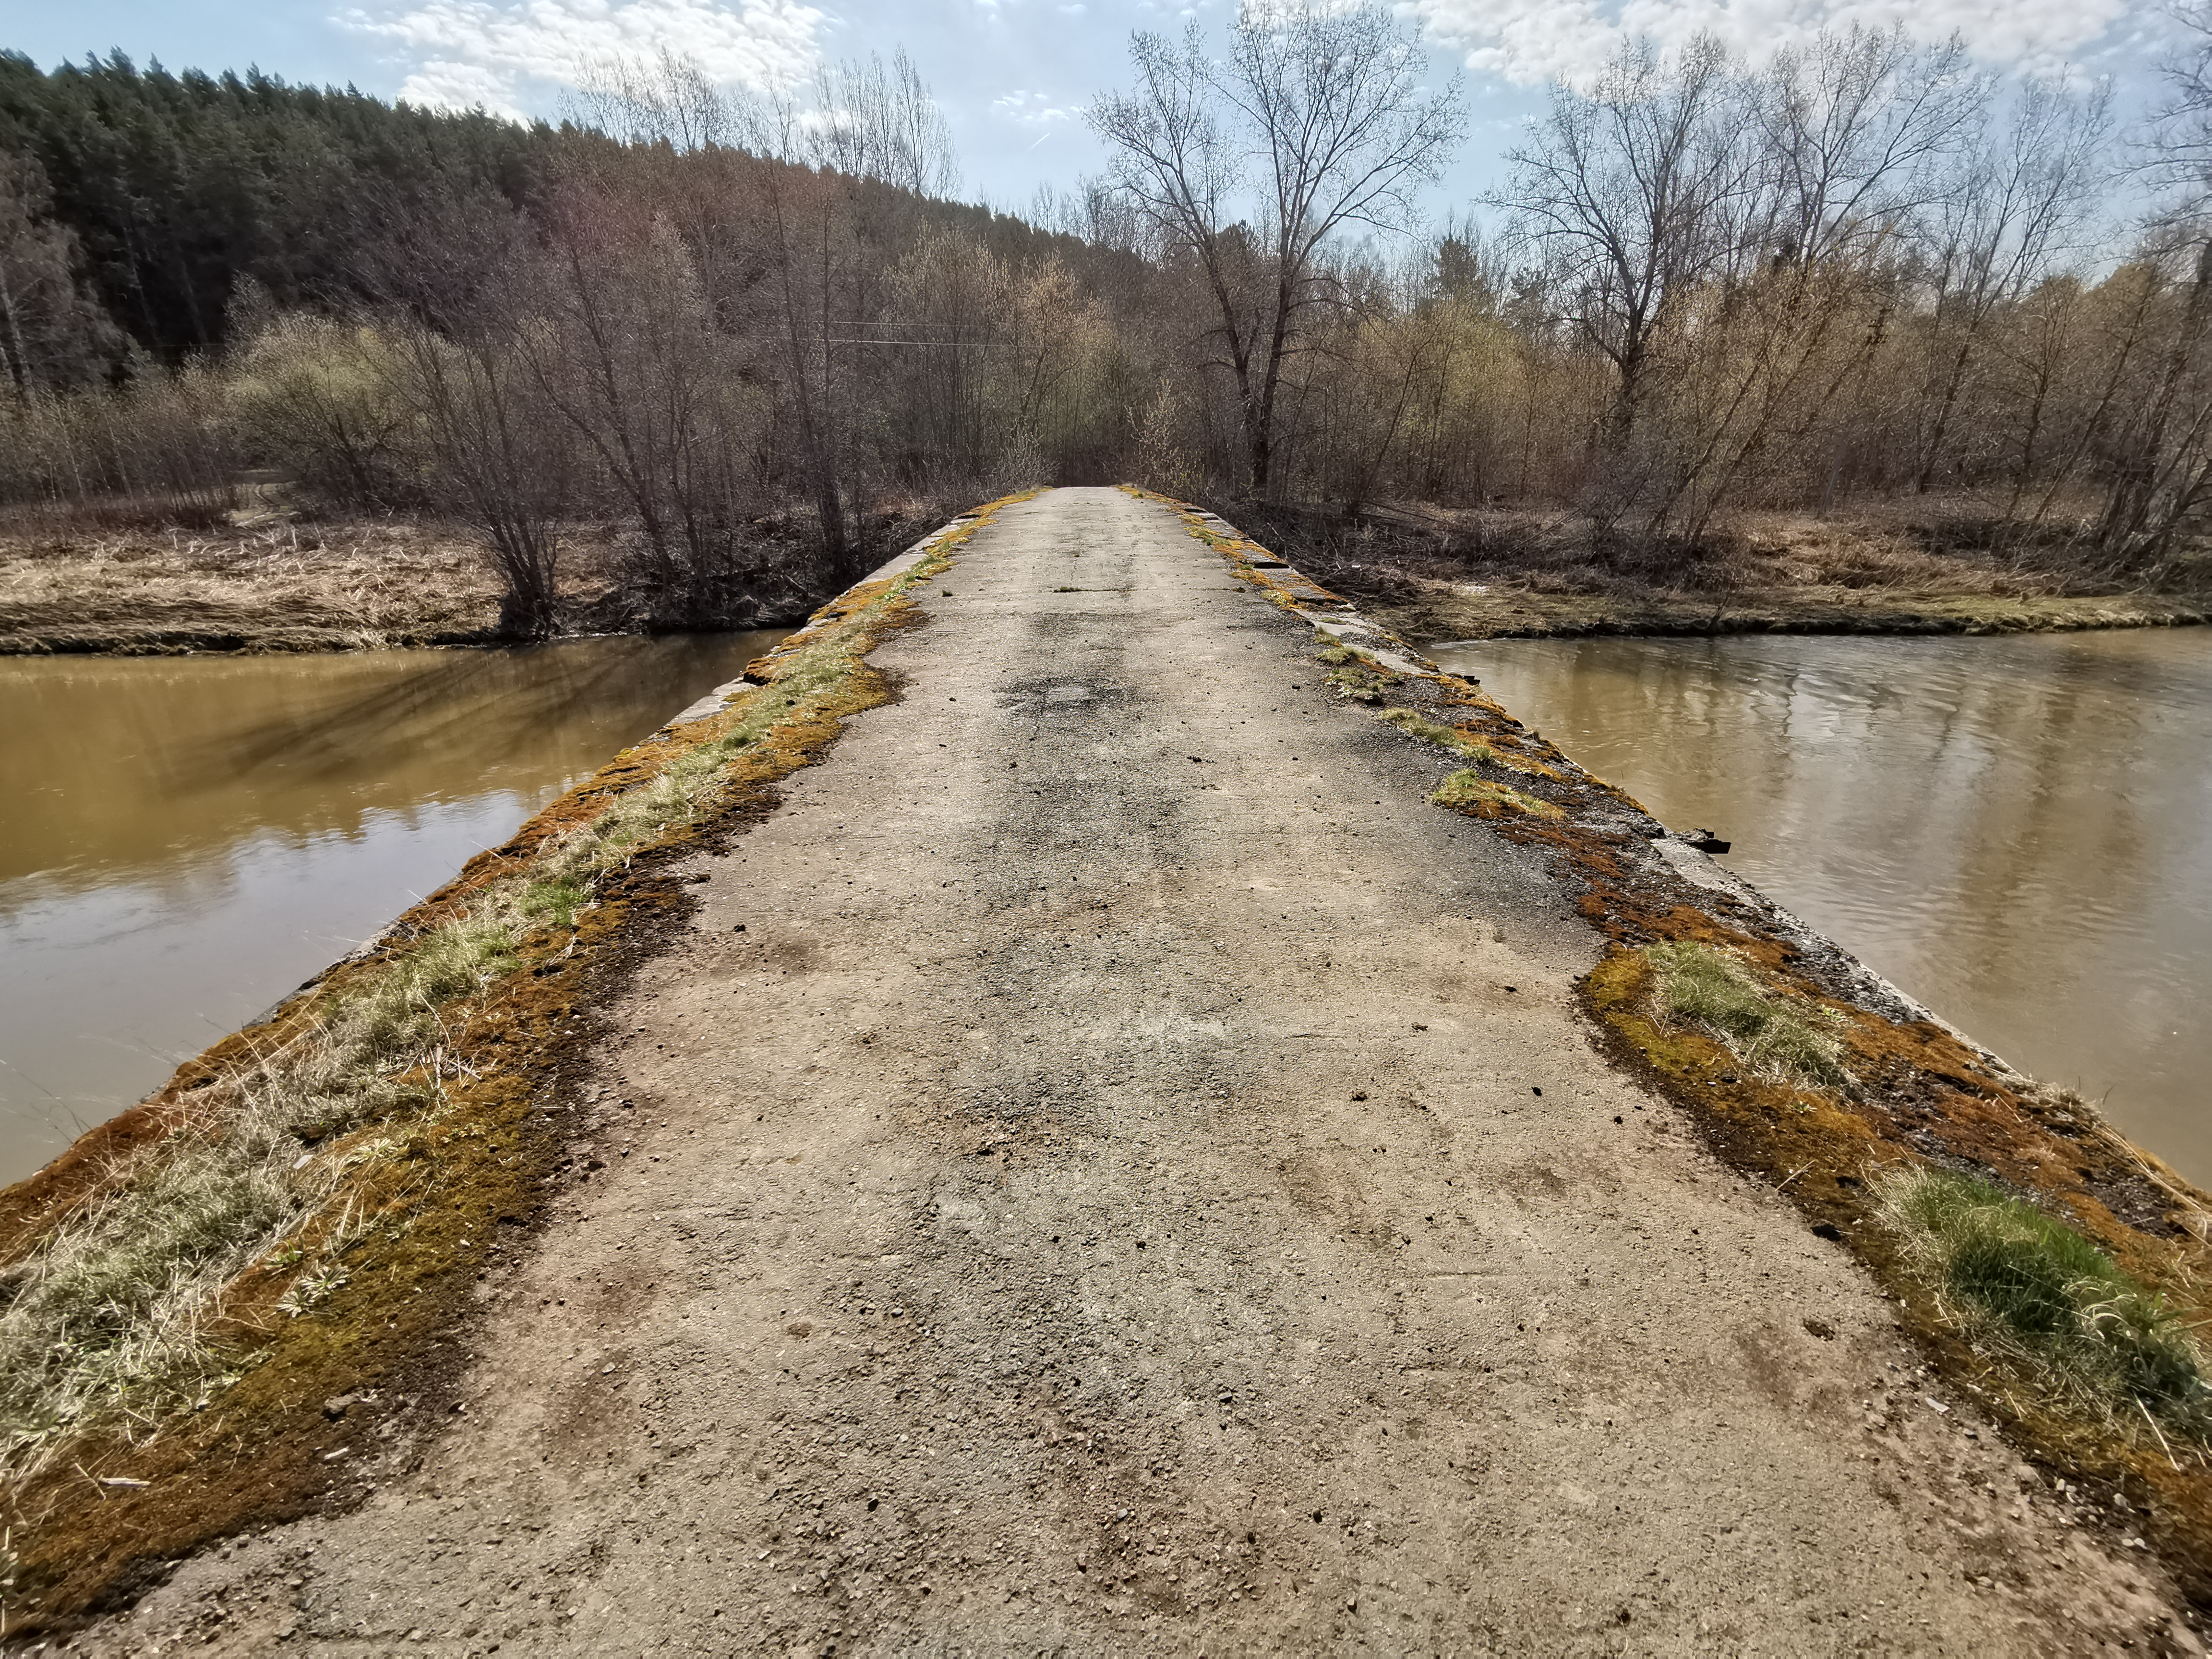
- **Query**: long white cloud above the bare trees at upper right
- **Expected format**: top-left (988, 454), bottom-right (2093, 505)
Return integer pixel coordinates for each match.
top-left (1411, 0), bottom-right (2128, 84)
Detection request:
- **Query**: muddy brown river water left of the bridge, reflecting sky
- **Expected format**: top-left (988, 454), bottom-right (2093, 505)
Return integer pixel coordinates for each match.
top-left (0, 633), bottom-right (783, 1181)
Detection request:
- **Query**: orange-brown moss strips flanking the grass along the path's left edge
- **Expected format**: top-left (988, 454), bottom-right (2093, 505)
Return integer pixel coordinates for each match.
top-left (0, 498), bottom-right (1020, 1635)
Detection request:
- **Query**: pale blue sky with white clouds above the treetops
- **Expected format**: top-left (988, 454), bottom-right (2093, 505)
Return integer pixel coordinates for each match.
top-left (0, 0), bottom-right (2172, 219)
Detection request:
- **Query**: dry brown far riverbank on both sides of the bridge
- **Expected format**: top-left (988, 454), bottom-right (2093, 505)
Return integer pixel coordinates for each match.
top-left (0, 502), bottom-right (2212, 657)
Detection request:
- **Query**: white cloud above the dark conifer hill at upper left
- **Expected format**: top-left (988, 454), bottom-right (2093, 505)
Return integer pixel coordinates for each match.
top-left (336, 0), bottom-right (827, 113)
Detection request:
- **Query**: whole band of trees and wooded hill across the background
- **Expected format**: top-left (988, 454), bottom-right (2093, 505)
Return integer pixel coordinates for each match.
top-left (0, 4), bottom-right (2212, 630)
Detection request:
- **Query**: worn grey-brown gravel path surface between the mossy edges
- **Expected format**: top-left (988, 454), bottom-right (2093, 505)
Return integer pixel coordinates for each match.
top-left (80, 489), bottom-right (2194, 1655)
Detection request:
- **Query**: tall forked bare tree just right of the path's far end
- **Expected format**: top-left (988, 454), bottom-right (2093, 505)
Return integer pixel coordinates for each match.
top-left (1088, 0), bottom-right (1464, 493)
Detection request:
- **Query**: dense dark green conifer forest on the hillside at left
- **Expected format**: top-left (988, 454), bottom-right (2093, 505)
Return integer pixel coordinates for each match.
top-left (0, 53), bottom-right (557, 358)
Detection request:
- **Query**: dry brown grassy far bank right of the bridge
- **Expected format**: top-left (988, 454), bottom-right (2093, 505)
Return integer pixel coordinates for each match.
top-left (1221, 500), bottom-right (2212, 641)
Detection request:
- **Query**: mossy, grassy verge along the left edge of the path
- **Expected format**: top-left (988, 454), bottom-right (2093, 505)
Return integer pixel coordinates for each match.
top-left (0, 497), bottom-right (1017, 1633)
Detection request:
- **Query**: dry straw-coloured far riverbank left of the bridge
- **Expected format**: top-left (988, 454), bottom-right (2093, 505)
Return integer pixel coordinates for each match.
top-left (0, 509), bottom-right (945, 657)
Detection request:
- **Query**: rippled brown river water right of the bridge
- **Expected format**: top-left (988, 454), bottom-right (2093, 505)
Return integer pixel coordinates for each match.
top-left (1433, 628), bottom-right (2212, 1186)
